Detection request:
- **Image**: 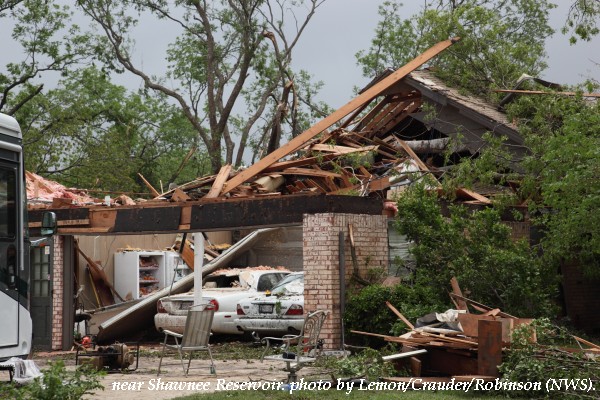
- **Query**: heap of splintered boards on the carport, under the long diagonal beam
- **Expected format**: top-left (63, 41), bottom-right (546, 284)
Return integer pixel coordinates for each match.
top-left (155, 71), bottom-right (490, 204)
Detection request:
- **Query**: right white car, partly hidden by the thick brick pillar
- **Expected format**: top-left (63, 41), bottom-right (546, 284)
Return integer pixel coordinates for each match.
top-left (235, 272), bottom-right (304, 334)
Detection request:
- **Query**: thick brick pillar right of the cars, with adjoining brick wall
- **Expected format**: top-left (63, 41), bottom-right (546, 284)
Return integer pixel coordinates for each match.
top-left (303, 213), bottom-right (389, 349)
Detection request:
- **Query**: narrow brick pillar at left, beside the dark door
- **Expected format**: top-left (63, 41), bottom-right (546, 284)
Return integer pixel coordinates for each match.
top-left (51, 236), bottom-right (64, 350)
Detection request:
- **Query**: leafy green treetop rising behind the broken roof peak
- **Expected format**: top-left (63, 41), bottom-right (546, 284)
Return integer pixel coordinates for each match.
top-left (357, 0), bottom-right (554, 96)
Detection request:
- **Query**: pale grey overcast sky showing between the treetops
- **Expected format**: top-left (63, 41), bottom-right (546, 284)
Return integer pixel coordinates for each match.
top-left (0, 0), bottom-right (600, 108)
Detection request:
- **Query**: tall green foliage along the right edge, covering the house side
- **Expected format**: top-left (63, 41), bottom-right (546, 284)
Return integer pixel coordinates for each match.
top-left (511, 91), bottom-right (600, 276)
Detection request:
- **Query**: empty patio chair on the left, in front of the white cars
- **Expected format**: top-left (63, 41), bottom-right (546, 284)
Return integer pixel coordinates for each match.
top-left (156, 310), bottom-right (216, 376)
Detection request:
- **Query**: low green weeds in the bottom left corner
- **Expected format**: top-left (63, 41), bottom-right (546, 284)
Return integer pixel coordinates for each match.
top-left (0, 360), bottom-right (104, 400)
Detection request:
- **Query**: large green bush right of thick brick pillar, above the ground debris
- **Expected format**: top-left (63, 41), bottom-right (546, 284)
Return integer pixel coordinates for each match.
top-left (396, 185), bottom-right (556, 317)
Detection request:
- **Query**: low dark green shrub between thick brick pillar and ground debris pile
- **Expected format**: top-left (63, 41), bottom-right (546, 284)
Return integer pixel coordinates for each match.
top-left (344, 285), bottom-right (448, 347)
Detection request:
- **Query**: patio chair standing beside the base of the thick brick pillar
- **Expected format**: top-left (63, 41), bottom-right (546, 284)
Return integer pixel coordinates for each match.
top-left (261, 310), bottom-right (329, 383)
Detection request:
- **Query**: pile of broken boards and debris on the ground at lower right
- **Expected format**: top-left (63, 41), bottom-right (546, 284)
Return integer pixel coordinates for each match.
top-left (351, 278), bottom-right (600, 382)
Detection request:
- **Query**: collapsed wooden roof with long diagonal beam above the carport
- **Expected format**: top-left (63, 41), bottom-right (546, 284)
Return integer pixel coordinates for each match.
top-left (31, 39), bottom-right (523, 233)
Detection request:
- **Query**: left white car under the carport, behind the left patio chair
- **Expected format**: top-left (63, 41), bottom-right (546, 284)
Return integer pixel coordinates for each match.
top-left (154, 267), bottom-right (290, 335)
